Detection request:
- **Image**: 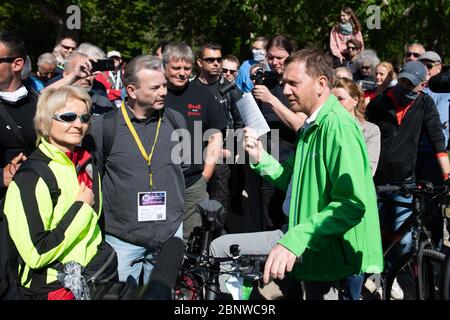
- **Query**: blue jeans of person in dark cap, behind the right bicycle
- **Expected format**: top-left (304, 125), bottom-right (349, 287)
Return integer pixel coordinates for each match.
top-left (379, 193), bottom-right (413, 268)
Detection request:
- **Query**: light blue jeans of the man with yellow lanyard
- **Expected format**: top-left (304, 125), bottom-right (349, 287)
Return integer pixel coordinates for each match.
top-left (105, 223), bottom-right (183, 285)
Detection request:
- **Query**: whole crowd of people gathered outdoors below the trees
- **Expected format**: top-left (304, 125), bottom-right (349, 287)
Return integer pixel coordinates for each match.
top-left (0, 7), bottom-right (450, 300)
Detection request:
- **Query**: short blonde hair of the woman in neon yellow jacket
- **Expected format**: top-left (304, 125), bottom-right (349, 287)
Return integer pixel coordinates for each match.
top-left (34, 86), bottom-right (92, 144)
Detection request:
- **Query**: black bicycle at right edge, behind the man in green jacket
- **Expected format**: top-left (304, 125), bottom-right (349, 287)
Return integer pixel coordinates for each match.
top-left (376, 182), bottom-right (448, 300)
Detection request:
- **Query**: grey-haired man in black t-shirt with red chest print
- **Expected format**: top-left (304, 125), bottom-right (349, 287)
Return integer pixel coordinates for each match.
top-left (163, 43), bottom-right (226, 241)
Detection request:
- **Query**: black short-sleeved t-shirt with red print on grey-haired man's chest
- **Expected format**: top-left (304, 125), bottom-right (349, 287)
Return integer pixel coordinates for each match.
top-left (164, 82), bottom-right (226, 187)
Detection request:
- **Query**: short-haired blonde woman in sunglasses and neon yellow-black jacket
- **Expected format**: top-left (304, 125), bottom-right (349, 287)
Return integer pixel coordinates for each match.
top-left (4, 86), bottom-right (117, 300)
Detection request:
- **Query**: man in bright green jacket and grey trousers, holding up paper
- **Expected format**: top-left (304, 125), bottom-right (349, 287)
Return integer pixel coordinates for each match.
top-left (211, 49), bottom-right (383, 299)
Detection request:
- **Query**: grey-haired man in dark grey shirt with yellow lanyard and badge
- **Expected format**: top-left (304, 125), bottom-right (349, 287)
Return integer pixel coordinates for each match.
top-left (91, 55), bottom-right (186, 283)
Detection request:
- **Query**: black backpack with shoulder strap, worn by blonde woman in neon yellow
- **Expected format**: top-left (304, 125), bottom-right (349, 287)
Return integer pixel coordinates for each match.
top-left (0, 149), bottom-right (61, 300)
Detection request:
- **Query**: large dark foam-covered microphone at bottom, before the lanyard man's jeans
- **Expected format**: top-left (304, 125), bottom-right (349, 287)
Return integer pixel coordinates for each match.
top-left (140, 237), bottom-right (184, 300)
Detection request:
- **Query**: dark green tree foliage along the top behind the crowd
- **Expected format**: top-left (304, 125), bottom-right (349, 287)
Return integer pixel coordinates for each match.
top-left (0, 0), bottom-right (450, 62)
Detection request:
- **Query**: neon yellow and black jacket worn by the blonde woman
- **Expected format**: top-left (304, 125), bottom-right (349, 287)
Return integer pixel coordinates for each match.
top-left (4, 139), bottom-right (102, 294)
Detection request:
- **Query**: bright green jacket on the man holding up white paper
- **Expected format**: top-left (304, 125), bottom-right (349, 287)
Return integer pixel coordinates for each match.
top-left (252, 95), bottom-right (383, 281)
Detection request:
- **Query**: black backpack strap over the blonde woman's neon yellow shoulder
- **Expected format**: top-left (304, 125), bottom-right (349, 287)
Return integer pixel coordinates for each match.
top-left (18, 149), bottom-right (61, 208)
